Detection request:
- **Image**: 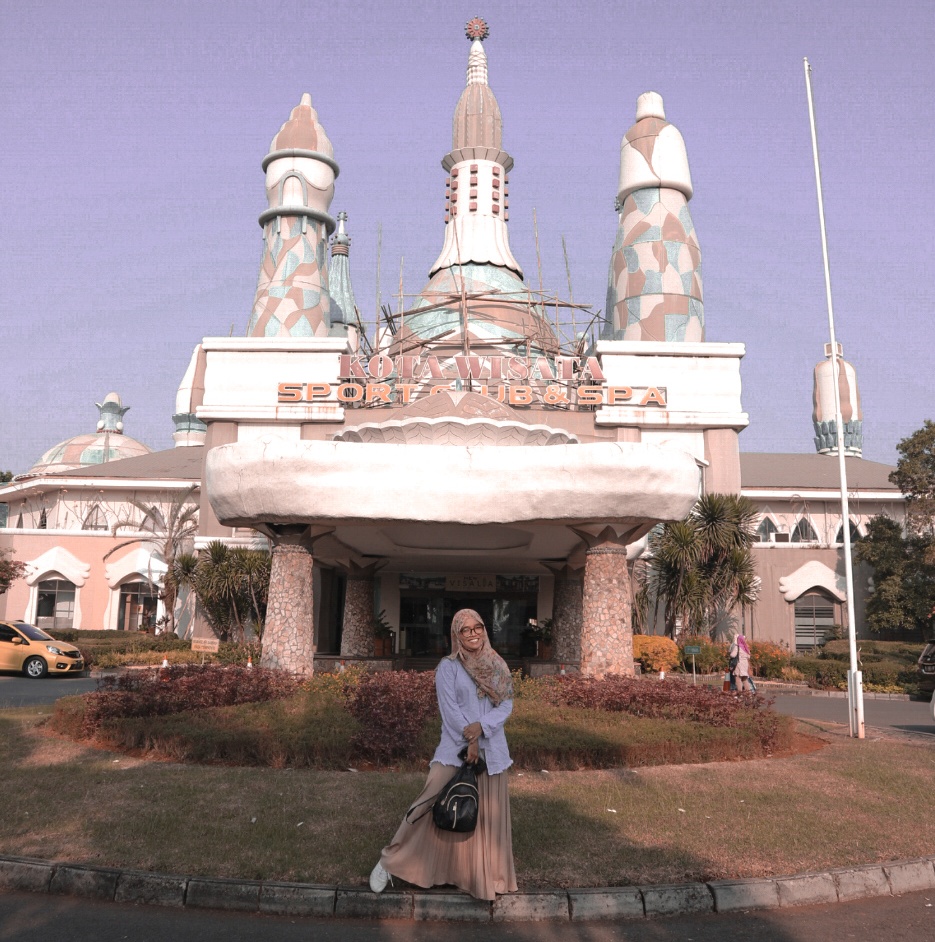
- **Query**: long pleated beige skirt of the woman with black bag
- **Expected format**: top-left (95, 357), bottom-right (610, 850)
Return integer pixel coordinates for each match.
top-left (380, 763), bottom-right (516, 899)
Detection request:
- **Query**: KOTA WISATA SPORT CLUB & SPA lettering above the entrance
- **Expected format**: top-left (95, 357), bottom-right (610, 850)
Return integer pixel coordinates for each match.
top-left (278, 354), bottom-right (668, 409)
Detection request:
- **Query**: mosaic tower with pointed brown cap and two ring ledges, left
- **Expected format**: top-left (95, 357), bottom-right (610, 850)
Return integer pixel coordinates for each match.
top-left (247, 93), bottom-right (338, 337)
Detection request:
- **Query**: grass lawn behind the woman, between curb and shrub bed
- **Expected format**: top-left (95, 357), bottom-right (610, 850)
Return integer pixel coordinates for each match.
top-left (0, 708), bottom-right (935, 889)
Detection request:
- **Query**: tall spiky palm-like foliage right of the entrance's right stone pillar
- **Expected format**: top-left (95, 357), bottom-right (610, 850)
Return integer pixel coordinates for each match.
top-left (636, 494), bottom-right (759, 637)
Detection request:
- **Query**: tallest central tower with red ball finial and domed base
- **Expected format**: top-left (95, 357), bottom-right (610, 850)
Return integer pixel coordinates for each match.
top-left (394, 17), bottom-right (558, 362)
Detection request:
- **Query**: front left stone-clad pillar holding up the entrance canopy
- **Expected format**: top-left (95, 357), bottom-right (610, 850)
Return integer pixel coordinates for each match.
top-left (260, 540), bottom-right (315, 675)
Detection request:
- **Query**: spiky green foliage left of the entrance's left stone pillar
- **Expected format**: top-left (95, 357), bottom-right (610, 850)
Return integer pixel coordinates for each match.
top-left (166, 540), bottom-right (272, 641)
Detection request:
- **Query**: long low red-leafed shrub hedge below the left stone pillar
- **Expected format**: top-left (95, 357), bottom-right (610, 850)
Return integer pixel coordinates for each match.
top-left (68, 665), bottom-right (299, 738)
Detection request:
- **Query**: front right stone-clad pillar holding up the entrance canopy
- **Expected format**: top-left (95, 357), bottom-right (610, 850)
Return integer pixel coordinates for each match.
top-left (581, 542), bottom-right (634, 677)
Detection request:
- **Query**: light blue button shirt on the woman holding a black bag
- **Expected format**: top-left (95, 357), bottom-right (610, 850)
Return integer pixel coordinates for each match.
top-left (432, 657), bottom-right (513, 775)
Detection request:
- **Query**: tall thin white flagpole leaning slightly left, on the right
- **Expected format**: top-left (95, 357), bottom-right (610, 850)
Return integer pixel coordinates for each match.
top-left (802, 59), bottom-right (864, 739)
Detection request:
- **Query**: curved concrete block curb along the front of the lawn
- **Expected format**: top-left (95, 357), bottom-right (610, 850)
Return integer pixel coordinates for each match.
top-left (0, 855), bottom-right (935, 922)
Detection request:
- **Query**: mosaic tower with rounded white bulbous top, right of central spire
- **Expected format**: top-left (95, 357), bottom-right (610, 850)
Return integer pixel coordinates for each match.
top-left (603, 92), bottom-right (704, 341)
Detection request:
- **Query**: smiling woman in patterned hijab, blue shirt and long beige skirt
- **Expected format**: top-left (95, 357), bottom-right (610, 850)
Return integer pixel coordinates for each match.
top-left (370, 608), bottom-right (516, 899)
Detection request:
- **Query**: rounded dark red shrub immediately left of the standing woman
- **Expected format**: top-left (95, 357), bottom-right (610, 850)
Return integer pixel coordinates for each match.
top-left (348, 671), bottom-right (438, 762)
